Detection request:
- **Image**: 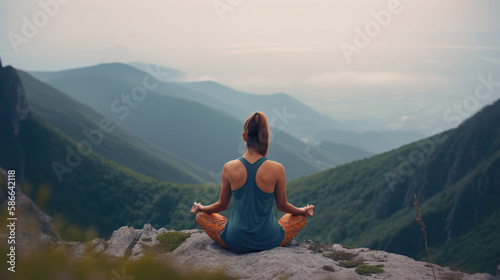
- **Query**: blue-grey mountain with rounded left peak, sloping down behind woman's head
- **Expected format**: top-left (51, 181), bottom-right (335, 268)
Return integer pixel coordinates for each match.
top-left (28, 63), bottom-right (348, 178)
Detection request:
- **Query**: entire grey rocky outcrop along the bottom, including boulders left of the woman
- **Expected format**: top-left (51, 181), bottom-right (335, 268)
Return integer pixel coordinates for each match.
top-left (58, 224), bottom-right (500, 280)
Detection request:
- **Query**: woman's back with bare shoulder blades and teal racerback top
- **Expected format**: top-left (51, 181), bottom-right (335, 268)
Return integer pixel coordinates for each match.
top-left (220, 157), bottom-right (285, 253)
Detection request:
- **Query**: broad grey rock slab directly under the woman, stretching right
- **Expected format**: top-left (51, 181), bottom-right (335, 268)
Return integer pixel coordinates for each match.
top-left (157, 231), bottom-right (494, 280)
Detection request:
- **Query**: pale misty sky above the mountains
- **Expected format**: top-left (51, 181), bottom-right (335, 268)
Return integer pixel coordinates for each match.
top-left (0, 0), bottom-right (500, 133)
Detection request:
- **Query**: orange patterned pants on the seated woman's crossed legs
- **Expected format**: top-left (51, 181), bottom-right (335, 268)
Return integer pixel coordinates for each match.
top-left (196, 212), bottom-right (307, 248)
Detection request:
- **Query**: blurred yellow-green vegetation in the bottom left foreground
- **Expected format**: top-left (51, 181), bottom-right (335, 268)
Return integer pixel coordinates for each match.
top-left (0, 244), bottom-right (231, 280)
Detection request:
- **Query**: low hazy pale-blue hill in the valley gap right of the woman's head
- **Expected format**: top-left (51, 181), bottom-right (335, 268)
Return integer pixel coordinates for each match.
top-left (312, 129), bottom-right (425, 154)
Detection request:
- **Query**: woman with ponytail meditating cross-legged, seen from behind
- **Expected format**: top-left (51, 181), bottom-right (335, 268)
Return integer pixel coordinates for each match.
top-left (191, 112), bottom-right (314, 253)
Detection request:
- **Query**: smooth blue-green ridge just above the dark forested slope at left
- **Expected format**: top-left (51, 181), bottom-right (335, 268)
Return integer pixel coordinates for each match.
top-left (18, 71), bottom-right (213, 183)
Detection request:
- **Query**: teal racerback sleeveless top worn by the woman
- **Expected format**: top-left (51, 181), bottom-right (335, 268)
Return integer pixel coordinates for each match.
top-left (220, 157), bottom-right (285, 253)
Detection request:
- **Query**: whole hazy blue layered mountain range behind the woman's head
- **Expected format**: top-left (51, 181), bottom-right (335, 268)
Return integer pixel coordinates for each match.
top-left (31, 63), bottom-right (371, 178)
